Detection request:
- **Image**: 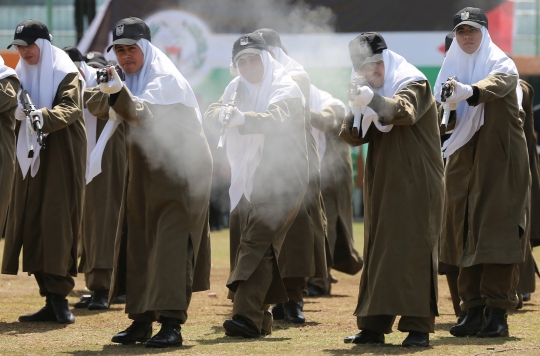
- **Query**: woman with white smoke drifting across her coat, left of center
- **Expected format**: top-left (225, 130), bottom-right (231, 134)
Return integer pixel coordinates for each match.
top-left (86, 17), bottom-right (212, 348)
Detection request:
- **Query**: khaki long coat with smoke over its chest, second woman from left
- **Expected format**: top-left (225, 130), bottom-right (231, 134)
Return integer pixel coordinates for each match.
top-left (86, 87), bottom-right (212, 314)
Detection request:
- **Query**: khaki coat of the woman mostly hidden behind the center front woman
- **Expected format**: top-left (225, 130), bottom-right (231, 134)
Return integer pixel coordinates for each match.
top-left (278, 76), bottom-right (332, 278)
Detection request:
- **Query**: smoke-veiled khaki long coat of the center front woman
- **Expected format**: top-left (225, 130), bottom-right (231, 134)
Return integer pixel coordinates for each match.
top-left (204, 98), bottom-right (309, 304)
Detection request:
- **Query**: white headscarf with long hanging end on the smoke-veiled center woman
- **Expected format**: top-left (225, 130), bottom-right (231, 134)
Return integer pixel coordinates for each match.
top-left (219, 50), bottom-right (305, 211)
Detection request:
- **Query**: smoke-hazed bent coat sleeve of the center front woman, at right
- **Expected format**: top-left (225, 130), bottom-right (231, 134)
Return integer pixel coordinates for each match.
top-left (238, 98), bottom-right (304, 135)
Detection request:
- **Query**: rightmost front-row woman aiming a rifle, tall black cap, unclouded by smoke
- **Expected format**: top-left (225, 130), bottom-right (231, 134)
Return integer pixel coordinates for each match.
top-left (435, 7), bottom-right (530, 337)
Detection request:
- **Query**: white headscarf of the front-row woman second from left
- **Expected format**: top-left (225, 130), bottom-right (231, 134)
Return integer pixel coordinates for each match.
top-left (119, 38), bottom-right (202, 124)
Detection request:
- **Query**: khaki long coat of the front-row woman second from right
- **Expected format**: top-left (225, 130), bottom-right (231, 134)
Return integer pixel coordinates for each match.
top-left (340, 81), bottom-right (444, 317)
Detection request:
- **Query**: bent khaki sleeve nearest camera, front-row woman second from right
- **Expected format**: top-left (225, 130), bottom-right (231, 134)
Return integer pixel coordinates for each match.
top-left (368, 80), bottom-right (434, 125)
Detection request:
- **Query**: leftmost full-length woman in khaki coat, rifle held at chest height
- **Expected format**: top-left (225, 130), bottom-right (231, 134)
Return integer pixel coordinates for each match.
top-left (2, 20), bottom-right (86, 324)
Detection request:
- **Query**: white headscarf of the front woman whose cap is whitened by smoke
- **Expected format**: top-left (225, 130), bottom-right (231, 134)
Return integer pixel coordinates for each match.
top-left (349, 49), bottom-right (427, 137)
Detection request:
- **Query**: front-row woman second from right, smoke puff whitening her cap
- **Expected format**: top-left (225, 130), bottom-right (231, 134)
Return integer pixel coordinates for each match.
top-left (340, 32), bottom-right (443, 347)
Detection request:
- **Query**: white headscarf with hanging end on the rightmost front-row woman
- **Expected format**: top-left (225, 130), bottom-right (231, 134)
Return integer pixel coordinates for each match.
top-left (434, 26), bottom-right (521, 157)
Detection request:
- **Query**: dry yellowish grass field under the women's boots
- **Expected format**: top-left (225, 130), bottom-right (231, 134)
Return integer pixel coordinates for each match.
top-left (0, 224), bottom-right (540, 356)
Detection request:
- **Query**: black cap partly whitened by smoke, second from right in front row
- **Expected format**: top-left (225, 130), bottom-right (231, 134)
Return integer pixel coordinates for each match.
top-left (349, 32), bottom-right (388, 70)
